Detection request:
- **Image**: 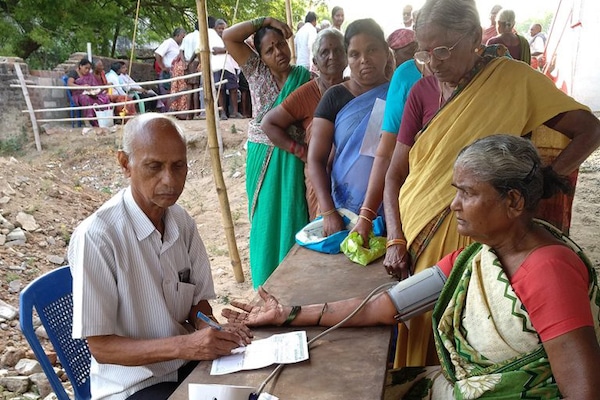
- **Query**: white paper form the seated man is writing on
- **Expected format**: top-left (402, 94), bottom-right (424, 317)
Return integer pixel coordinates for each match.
top-left (210, 331), bottom-right (308, 375)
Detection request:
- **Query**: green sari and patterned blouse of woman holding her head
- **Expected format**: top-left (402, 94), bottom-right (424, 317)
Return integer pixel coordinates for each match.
top-left (242, 54), bottom-right (310, 288)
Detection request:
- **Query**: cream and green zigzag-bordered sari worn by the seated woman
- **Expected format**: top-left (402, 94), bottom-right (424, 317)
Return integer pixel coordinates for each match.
top-left (385, 220), bottom-right (600, 400)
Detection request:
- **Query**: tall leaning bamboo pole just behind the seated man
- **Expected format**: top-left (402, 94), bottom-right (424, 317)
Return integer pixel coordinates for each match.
top-left (196, 0), bottom-right (244, 283)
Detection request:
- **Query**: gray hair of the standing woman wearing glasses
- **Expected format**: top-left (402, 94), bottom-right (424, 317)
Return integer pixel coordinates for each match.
top-left (415, 0), bottom-right (481, 34)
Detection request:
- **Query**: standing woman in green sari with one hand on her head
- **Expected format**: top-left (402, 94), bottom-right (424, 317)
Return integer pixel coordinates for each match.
top-left (223, 17), bottom-right (310, 288)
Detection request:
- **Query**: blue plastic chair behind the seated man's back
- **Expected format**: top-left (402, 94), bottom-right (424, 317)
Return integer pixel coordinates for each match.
top-left (19, 266), bottom-right (91, 400)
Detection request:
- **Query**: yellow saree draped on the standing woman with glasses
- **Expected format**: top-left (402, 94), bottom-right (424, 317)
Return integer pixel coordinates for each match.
top-left (395, 57), bottom-right (586, 367)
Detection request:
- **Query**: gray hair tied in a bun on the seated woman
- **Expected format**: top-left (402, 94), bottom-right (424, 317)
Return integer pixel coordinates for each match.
top-left (454, 134), bottom-right (571, 211)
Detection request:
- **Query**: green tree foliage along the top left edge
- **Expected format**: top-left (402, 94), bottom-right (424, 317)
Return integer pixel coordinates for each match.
top-left (0, 0), bottom-right (318, 69)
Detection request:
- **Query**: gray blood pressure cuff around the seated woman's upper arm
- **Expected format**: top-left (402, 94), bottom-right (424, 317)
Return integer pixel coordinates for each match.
top-left (388, 265), bottom-right (446, 321)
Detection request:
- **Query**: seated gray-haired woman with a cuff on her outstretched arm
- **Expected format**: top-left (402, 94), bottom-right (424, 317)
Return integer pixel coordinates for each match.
top-left (223, 135), bottom-right (600, 400)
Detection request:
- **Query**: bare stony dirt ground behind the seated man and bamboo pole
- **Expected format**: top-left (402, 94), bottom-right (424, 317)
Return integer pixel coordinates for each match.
top-left (0, 119), bottom-right (600, 353)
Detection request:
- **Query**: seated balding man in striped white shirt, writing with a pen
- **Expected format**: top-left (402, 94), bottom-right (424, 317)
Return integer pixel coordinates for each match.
top-left (69, 113), bottom-right (251, 400)
